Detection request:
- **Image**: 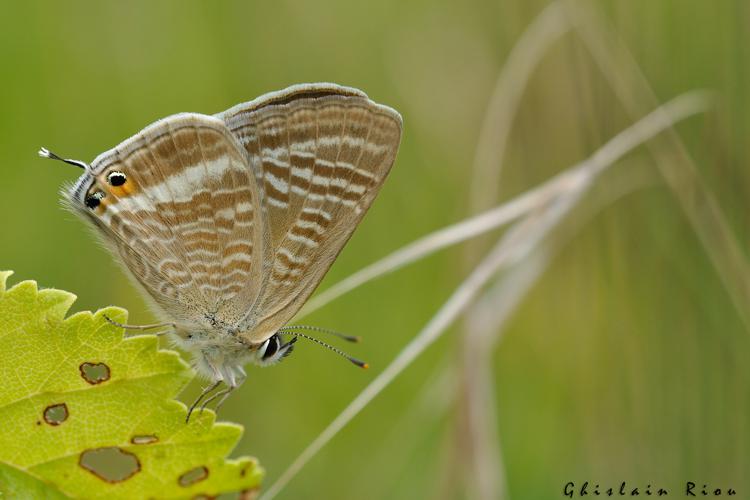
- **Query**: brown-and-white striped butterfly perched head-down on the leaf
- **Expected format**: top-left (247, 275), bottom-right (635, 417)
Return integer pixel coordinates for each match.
top-left (39, 83), bottom-right (402, 419)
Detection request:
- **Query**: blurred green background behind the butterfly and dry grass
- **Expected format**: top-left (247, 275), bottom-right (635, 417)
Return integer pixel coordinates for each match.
top-left (0, 0), bottom-right (750, 499)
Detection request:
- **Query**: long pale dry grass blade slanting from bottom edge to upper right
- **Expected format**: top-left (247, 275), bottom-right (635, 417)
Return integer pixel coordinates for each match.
top-left (261, 92), bottom-right (709, 500)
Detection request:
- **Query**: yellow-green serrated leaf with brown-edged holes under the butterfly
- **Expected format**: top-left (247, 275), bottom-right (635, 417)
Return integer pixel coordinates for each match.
top-left (0, 272), bottom-right (263, 499)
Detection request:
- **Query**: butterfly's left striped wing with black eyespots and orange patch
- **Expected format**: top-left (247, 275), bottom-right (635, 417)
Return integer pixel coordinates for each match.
top-left (69, 113), bottom-right (265, 327)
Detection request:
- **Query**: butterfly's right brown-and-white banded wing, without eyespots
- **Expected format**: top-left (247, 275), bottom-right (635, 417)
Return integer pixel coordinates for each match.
top-left (217, 84), bottom-right (402, 343)
